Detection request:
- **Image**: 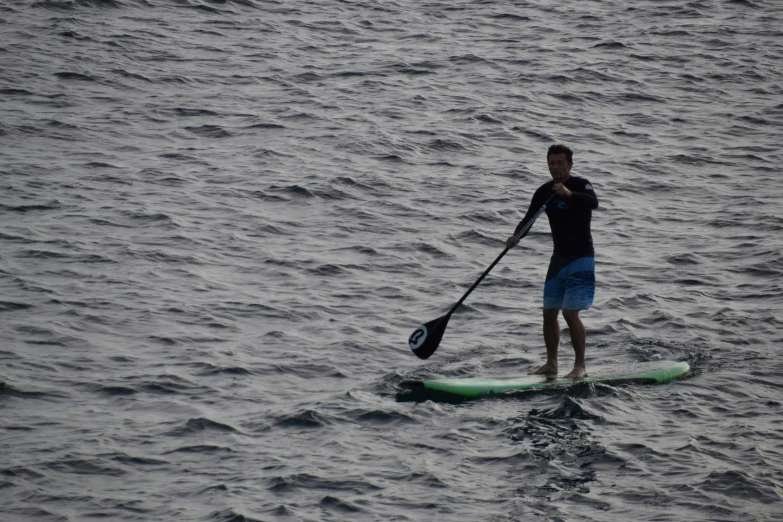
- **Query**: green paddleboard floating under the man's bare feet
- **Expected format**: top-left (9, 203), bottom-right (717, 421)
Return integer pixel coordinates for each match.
top-left (400, 361), bottom-right (691, 397)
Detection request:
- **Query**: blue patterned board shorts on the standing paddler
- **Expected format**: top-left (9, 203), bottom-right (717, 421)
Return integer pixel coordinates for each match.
top-left (544, 255), bottom-right (595, 310)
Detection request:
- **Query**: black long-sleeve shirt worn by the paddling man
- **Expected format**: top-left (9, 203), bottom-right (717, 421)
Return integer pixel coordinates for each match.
top-left (514, 176), bottom-right (598, 258)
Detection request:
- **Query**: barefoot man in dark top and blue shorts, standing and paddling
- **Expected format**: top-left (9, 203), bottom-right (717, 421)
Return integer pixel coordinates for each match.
top-left (506, 145), bottom-right (598, 379)
